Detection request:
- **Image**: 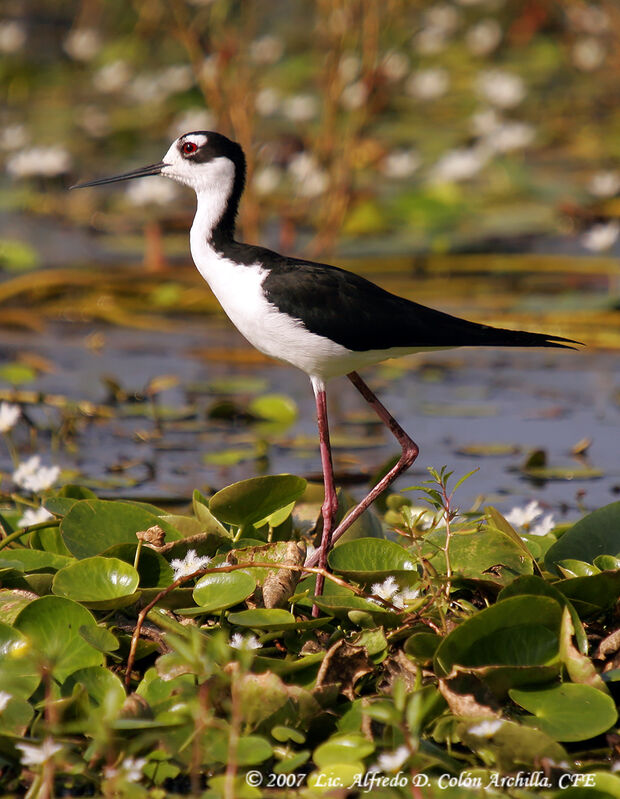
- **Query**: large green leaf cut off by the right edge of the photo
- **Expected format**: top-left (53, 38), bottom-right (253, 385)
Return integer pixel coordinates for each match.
top-left (545, 502), bottom-right (620, 574)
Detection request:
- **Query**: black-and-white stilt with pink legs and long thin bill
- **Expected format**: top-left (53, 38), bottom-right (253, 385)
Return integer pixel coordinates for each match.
top-left (74, 131), bottom-right (577, 593)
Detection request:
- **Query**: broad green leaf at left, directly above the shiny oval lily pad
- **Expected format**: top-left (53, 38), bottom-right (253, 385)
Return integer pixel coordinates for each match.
top-left (60, 499), bottom-right (181, 558)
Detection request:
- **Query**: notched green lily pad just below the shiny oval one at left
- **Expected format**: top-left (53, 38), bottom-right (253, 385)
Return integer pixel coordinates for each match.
top-left (14, 596), bottom-right (103, 683)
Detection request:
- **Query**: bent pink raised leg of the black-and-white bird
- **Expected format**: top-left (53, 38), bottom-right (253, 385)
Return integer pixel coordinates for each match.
top-left (306, 372), bottom-right (419, 572)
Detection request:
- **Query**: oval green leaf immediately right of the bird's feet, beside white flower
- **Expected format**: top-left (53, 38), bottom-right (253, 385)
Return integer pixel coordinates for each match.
top-left (328, 538), bottom-right (417, 582)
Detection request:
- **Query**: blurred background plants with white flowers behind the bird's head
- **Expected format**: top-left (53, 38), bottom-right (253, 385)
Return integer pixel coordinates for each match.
top-left (0, 0), bottom-right (620, 254)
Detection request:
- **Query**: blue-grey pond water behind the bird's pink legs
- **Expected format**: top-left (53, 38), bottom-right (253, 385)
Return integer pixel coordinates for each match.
top-left (1, 318), bottom-right (620, 516)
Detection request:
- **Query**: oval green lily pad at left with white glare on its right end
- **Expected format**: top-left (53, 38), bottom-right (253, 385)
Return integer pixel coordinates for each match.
top-left (52, 555), bottom-right (140, 609)
